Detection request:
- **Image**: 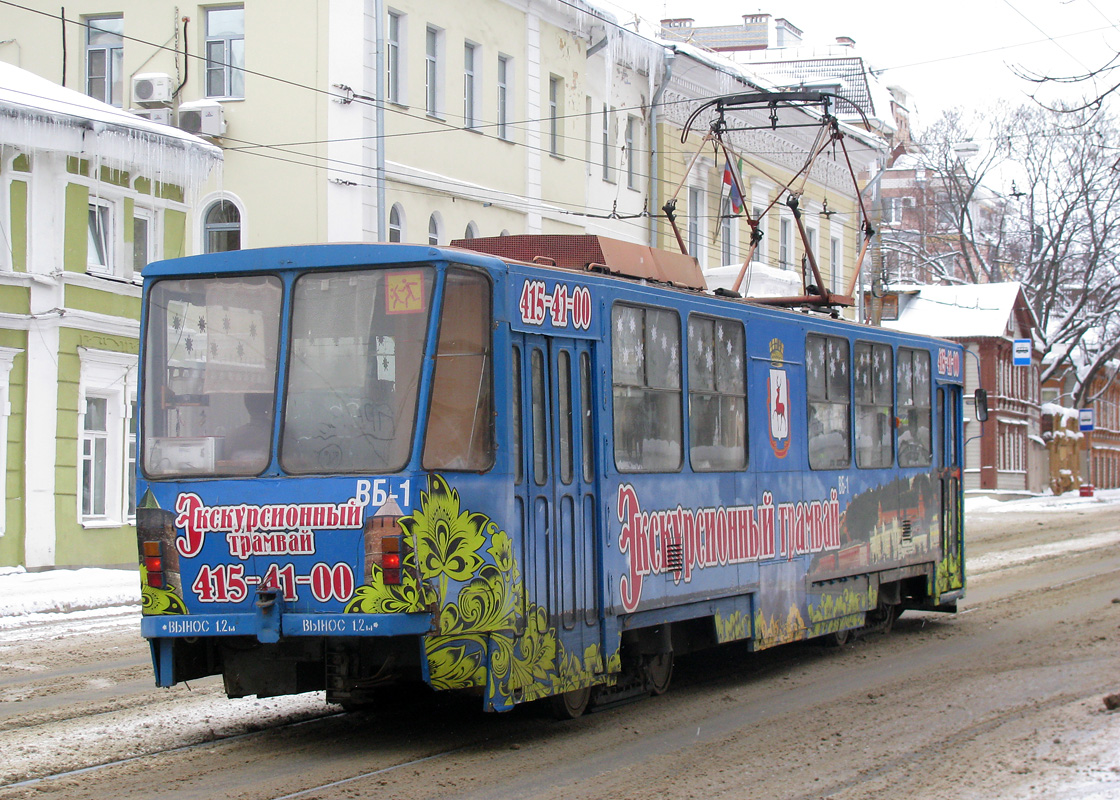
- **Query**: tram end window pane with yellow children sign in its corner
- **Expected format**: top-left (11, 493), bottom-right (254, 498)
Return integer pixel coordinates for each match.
top-left (280, 268), bottom-right (432, 474)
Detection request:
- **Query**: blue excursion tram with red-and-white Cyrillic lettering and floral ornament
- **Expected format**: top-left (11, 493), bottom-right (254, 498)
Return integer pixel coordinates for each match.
top-left (137, 236), bottom-right (964, 716)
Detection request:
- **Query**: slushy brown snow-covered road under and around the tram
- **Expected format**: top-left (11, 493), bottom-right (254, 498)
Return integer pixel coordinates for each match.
top-left (0, 496), bottom-right (1120, 800)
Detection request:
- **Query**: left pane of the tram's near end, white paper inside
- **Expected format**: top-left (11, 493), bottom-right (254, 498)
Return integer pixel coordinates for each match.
top-left (142, 276), bottom-right (281, 477)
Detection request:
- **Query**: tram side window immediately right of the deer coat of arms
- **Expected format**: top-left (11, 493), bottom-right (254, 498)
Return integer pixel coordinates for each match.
top-left (805, 335), bottom-right (851, 469)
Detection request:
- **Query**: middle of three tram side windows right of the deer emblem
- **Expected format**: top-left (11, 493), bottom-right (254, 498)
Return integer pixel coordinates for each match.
top-left (855, 342), bottom-right (894, 469)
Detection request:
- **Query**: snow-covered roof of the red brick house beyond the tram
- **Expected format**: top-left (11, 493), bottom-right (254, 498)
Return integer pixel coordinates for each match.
top-left (883, 281), bottom-right (1023, 338)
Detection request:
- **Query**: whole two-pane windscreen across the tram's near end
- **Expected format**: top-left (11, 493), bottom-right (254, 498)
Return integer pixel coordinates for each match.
top-left (142, 268), bottom-right (433, 477)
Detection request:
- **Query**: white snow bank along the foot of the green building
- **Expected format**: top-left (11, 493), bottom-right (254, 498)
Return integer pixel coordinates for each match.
top-left (0, 567), bottom-right (140, 616)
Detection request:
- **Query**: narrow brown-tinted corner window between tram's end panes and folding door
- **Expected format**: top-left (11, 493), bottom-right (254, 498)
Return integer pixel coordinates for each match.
top-left (423, 269), bottom-right (494, 472)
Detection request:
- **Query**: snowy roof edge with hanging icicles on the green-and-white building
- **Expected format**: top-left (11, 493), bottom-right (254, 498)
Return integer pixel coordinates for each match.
top-left (0, 62), bottom-right (222, 186)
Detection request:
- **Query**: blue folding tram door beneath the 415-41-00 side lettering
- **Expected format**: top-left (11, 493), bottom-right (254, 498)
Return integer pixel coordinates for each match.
top-left (514, 335), bottom-right (601, 659)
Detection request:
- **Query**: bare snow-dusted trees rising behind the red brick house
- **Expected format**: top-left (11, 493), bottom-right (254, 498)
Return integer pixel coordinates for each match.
top-left (883, 105), bottom-right (1120, 404)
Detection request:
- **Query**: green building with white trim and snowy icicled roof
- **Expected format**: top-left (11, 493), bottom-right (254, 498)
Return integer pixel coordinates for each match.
top-left (0, 62), bottom-right (222, 569)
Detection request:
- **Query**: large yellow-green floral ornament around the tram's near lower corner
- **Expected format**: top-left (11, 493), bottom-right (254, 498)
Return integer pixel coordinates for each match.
top-left (346, 475), bottom-right (620, 708)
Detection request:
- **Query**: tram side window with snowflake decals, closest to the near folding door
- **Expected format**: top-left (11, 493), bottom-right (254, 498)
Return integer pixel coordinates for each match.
top-left (610, 304), bottom-right (683, 472)
